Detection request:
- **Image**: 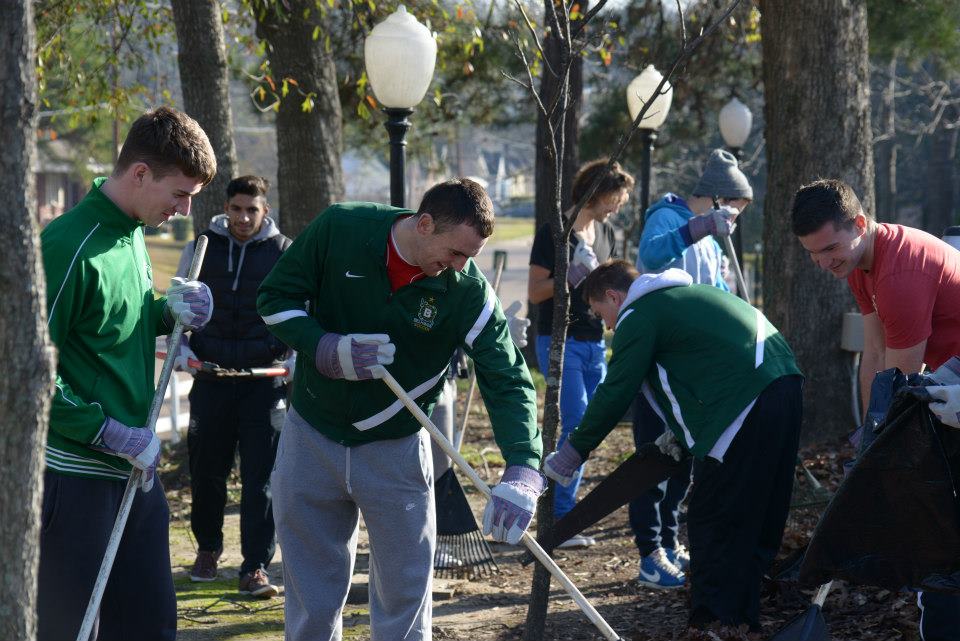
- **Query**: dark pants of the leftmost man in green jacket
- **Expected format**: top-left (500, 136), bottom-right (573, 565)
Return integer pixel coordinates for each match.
top-left (37, 470), bottom-right (177, 641)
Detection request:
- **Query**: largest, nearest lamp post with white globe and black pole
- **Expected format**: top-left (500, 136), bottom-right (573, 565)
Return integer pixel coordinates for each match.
top-left (363, 5), bottom-right (437, 207)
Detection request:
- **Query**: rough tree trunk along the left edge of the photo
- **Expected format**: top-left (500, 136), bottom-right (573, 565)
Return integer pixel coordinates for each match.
top-left (0, 0), bottom-right (54, 640)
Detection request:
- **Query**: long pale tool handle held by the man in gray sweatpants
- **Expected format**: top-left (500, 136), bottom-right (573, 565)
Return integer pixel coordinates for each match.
top-left (376, 365), bottom-right (622, 641)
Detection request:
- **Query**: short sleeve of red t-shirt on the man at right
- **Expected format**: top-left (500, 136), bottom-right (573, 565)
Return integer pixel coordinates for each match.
top-left (865, 271), bottom-right (940, 349)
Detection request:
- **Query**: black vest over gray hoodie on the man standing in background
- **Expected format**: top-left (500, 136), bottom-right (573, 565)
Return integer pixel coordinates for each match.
top-left (177, 214), bottom-right (291, 369)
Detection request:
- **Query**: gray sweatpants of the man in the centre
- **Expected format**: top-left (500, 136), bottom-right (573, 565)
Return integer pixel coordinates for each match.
top-left (270, 408), bottom-right (436, 641)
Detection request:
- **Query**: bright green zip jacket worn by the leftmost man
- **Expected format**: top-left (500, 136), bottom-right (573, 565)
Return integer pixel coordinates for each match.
top-left (40, 178), bottom-right (171, 479)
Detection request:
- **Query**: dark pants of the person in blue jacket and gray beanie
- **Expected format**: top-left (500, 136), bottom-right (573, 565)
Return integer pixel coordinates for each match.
top-left (628, 393), bottom-right (690, 556)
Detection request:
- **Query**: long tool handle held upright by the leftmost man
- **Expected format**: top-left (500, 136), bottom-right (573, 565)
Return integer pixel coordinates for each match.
top-left (77, 236), bottom-right (207, 641)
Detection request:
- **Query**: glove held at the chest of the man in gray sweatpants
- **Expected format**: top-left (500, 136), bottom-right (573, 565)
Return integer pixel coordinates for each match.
top-left (316, 332), bottom-right (397, 381)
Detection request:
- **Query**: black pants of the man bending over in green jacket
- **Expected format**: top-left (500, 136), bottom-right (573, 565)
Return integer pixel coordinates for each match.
top-left (687, 376), bottom-right (803, 631)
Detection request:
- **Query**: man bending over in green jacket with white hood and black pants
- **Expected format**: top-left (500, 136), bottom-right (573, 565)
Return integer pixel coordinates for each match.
top-left (544, 261), bottom-right (803, 631)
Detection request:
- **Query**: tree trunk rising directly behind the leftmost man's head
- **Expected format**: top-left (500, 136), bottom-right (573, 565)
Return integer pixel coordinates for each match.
top-left (171, 0), bottom-right (237, 234)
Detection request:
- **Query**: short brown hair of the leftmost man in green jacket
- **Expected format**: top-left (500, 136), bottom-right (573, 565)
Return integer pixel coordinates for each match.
top-left (113, 107), bottom-right (217, 185)
